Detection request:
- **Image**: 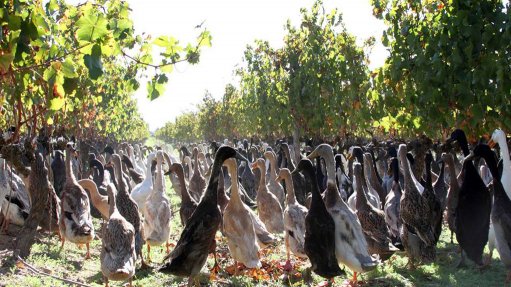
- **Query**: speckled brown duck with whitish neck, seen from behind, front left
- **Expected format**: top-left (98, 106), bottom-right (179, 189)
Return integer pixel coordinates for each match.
top-left (99, 184), bottom-right (137, 287)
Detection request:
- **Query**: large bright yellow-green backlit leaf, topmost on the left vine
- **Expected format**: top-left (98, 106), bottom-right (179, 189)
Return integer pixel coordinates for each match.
top-left (76, 10), bottom-right (108, 42)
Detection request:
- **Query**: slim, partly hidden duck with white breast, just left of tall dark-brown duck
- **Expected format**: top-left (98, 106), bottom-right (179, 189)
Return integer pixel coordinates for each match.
top-left (383, 157), bottom-right (403, 249)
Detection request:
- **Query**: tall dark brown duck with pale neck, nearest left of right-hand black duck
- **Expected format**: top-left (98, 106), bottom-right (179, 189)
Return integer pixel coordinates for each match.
top-left (398, 144), bottom-right (436, 268)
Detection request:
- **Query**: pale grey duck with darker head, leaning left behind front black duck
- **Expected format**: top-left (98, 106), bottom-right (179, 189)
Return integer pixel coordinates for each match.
top-left (308, 144), bottom-right (378, 283)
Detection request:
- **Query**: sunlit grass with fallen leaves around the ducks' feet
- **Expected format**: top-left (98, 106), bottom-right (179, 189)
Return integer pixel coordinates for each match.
top-left (0, 176), bottom-right (506, 287)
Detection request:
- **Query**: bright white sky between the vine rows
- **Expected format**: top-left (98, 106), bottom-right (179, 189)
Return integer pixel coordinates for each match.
top-left (128, 0), bottom-right (388, 131)
